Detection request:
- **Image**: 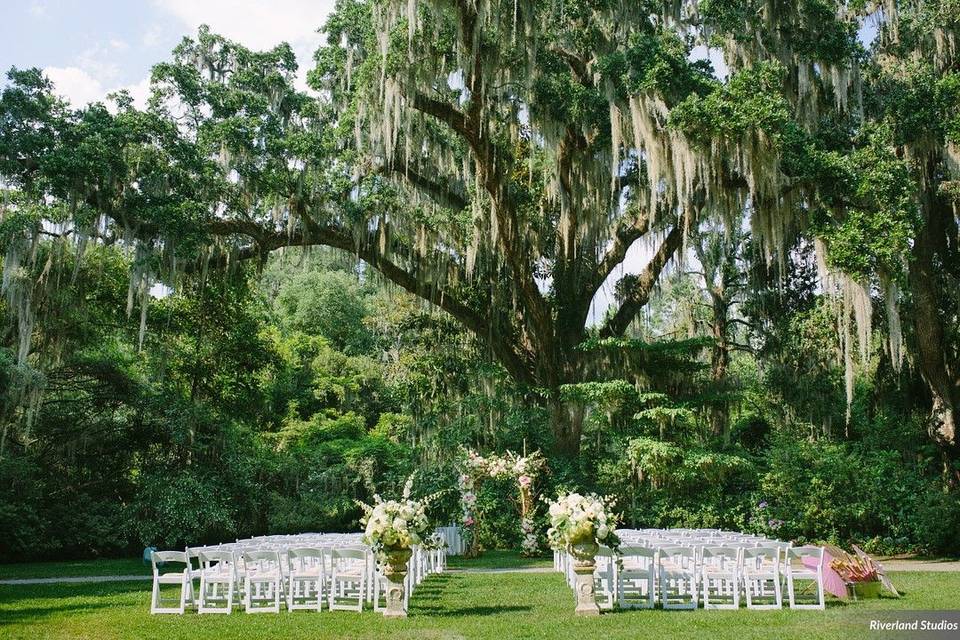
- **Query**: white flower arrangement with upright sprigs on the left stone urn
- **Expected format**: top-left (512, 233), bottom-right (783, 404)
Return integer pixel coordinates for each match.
top-left (357, 475), bottom-right (440, 560)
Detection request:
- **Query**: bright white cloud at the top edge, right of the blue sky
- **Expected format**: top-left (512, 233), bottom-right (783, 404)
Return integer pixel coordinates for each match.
top-left (154, 0), bottom-right (334, 51)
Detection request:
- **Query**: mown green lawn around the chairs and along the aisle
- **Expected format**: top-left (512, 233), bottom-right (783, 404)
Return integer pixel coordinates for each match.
top-left (0, 558), bottom-right (960, 640)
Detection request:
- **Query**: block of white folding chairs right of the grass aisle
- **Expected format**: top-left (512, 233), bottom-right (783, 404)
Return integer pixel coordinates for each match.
top-left (555, 544), bottom-right (825, 609)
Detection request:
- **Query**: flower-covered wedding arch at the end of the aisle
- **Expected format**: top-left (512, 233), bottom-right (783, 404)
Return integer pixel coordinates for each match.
top-left (458, 449), bottom-right (546, 557)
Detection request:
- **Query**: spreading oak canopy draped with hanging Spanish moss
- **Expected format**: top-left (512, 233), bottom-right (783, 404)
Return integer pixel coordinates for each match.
top-left (0, 0), bottom-right (960, 460)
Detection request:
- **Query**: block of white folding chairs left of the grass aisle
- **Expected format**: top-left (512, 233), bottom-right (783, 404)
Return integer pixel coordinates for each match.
top-left (150, 540), bottom-right (446, 614)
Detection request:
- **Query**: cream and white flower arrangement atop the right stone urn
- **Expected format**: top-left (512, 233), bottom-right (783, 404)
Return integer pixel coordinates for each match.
top-left (547, 493), bottom-right (620, 549)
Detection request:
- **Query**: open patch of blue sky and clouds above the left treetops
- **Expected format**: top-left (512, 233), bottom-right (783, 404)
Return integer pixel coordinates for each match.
top-left (0, 0), bottom-right (334, 106)
